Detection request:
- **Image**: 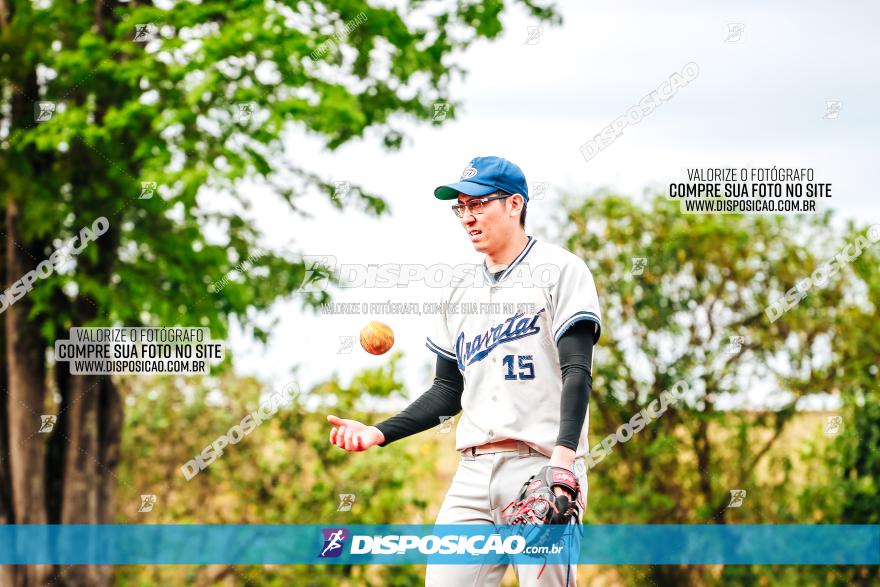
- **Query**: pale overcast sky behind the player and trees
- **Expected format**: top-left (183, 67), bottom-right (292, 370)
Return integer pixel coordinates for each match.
top-left (222, 2), bottom-right (880, 414)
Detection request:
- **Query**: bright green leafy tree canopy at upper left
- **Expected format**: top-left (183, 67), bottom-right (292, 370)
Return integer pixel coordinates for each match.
top-left (0, 0), bottom-right (559, 344)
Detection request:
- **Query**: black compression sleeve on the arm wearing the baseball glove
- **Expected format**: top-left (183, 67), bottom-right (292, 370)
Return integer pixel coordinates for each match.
top-left (556, 320), bottom-right (595, 450)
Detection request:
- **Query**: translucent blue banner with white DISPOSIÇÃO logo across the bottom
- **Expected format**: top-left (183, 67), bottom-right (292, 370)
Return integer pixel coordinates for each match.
top-left (0, 524), bottom-right (880, 565)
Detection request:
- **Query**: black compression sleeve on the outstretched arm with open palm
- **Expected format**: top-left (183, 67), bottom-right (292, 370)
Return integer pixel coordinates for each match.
top-left (376, 356), bottom-right (464, 446)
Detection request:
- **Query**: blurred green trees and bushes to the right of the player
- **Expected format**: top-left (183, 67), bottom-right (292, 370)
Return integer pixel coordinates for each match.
top-left (562, 193), bottom-right (880, 585)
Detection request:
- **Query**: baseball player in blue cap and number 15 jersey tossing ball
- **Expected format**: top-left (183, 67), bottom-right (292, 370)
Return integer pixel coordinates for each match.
top-left (327, 157), bottom-right (601, 587)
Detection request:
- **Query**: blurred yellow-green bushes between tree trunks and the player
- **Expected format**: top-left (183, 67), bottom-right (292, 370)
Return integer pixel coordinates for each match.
top-left (117, 358), bottom-right (441, 585)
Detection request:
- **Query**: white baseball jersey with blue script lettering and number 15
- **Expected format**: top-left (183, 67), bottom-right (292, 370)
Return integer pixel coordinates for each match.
top-left (426, 237), bottom-right (601, 457)
